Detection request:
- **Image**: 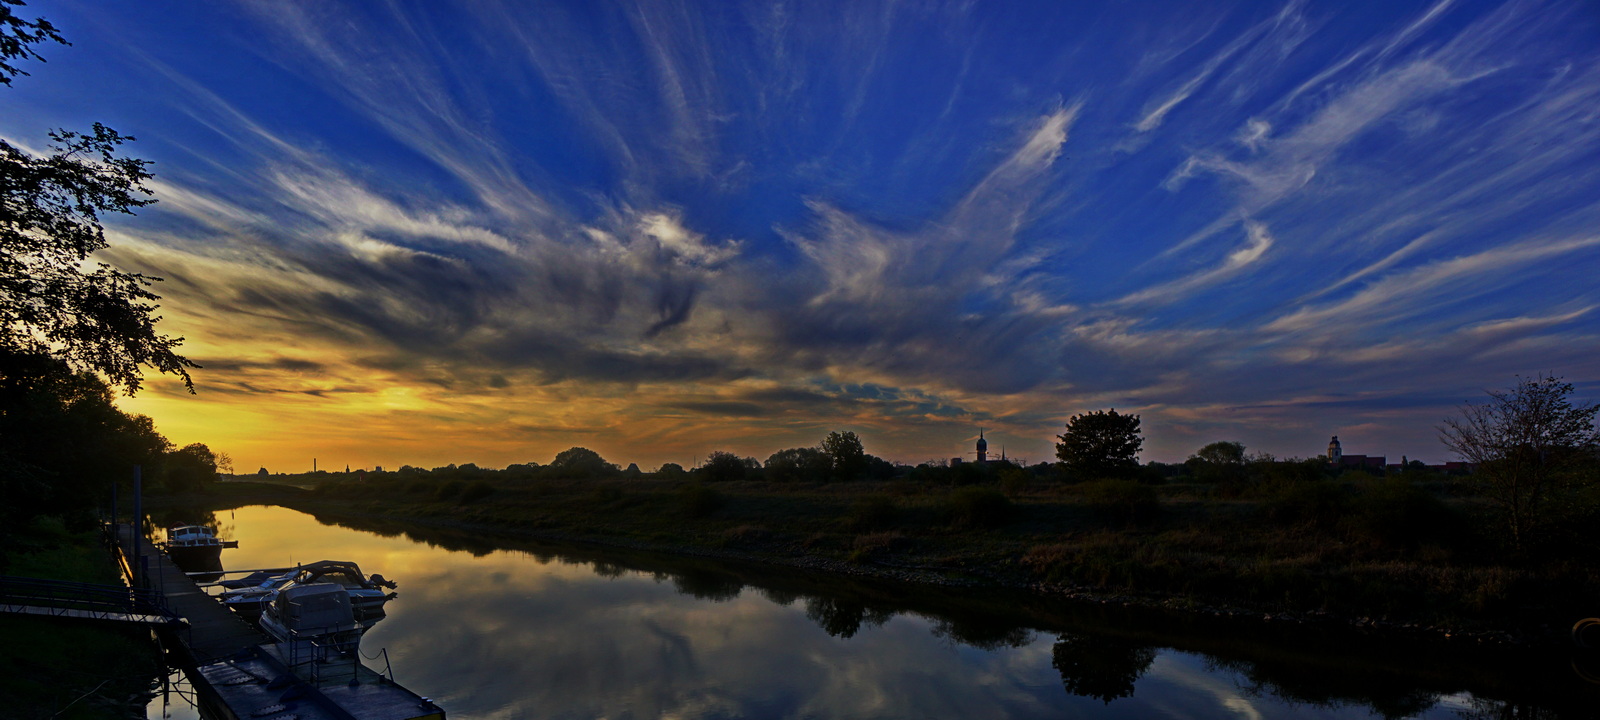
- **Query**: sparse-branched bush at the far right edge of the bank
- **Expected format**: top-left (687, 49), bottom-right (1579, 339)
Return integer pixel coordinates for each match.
top-left (1438, 374), bottom-right (1600, 550)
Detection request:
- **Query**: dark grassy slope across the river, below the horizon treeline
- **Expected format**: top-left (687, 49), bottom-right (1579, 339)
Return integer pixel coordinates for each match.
top-left (193, 475), bottom-right (1600, 642)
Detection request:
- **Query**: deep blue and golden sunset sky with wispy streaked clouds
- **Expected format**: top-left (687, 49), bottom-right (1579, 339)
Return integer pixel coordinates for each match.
top-left (0, 0), bottom-right (1600, 472)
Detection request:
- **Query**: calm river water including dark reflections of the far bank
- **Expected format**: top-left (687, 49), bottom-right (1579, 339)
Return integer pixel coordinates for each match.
top-left (150, 507), bottom-right (1600, 718)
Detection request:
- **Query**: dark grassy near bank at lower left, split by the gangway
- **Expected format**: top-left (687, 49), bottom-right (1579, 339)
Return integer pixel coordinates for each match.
top-left (0, 517), bottom-right (165, 718)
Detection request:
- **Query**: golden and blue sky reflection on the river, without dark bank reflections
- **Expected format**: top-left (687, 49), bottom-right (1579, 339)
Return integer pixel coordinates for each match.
top-left (165, 507), bottom-right (1574, 720)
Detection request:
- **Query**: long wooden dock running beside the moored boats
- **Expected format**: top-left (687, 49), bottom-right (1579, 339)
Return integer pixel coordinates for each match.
top-left (115, 525), bottom-right (445, 720)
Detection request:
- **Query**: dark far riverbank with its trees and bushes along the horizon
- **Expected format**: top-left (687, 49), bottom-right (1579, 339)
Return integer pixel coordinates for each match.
top-left (232, 376), bottom-right (1600, 642)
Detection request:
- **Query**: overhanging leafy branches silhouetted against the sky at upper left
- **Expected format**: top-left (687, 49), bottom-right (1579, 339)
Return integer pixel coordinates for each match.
top-left (0, 3), bottom-right (197, 395)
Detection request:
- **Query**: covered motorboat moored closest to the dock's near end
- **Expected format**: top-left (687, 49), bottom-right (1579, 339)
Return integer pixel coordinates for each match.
top-left (258, 582), bottom-right (368, 659)
